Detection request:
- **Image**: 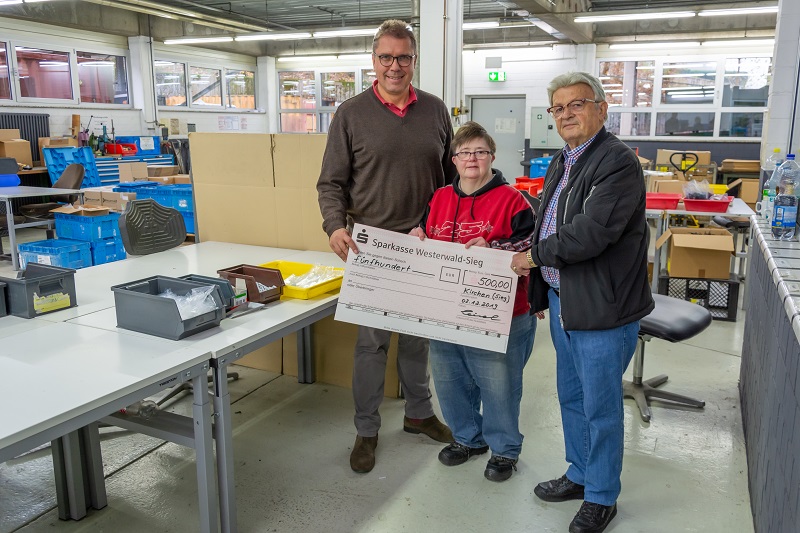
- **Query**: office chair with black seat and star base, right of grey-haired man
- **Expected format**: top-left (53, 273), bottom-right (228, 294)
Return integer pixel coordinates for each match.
top-left (622, 294), bottom-right (711, 422)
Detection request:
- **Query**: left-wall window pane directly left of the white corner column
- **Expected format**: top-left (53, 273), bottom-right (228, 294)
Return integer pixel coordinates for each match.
top-left (77, 52), bottom-right (130, 104)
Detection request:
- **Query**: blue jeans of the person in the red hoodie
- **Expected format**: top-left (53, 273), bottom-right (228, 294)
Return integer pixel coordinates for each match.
top-left (430, 313), bottom-right (536, 459)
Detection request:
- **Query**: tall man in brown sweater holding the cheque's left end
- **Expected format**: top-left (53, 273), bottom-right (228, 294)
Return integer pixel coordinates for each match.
top-left (317, 20), bottom-right (456, 473)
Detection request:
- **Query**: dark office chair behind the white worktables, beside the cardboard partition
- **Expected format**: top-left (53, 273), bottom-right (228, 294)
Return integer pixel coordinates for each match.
top-left (117, 198), bottom-right (239, 408)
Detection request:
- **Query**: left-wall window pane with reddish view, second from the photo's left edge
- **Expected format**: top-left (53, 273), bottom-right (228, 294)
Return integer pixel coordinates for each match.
top-left (14, 46), bottom-right (73, 101)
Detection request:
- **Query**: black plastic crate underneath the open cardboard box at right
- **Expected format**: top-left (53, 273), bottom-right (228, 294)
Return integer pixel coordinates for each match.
top-left (658, 276), bottom-right (739, 322)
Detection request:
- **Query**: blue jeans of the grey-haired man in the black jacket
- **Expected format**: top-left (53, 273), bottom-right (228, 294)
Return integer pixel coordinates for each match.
top-left (548, 289), bottom-right (639, 505)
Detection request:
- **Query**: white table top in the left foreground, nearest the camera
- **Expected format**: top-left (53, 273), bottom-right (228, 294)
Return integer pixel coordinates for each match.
top-left (0, 323), bottom-right (210, 457)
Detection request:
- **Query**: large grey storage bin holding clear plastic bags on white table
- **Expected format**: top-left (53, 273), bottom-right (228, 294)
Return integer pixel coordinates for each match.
top-left (111, 276), bottom-right (225, 341)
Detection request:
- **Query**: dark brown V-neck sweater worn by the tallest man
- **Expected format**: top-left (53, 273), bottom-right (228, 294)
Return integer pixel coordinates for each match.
top-left (317, 89), bottom-right (456, 236)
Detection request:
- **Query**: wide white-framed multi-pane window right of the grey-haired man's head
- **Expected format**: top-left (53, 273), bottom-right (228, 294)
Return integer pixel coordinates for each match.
top-left (598, 56), bottom-right (772, 138)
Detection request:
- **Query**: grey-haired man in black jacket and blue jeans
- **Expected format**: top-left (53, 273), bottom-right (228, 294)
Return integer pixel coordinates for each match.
top-left (511, 72), bottom-right (653, 533)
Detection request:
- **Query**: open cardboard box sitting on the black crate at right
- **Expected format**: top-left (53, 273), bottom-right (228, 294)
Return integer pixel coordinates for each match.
top-left (656, 228), bottom-right (734, 279)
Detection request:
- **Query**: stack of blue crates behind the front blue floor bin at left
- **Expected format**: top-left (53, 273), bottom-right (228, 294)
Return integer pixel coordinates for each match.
top-left (56, 213), bottom-right (127, 268)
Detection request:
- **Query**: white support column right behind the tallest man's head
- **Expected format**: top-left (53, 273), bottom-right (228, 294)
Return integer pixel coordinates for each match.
top-left (417, 0), bottom-right (464, 115)
